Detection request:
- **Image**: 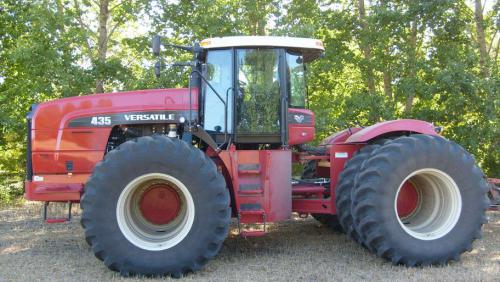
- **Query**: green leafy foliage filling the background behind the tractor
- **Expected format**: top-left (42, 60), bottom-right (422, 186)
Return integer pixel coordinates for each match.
top-left (0, 0), bottom-right (500, 202)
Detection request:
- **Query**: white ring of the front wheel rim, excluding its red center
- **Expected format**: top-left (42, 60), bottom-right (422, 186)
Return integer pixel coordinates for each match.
top-left (116, 173), bottom-right (195, 251)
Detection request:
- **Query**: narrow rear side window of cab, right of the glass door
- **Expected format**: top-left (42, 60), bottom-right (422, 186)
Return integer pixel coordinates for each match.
top-left (286, 51), bottom-right (306, 108)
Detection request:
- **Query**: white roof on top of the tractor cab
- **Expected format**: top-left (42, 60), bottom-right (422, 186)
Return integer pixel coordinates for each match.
top-left (200, 36), bottom-right (325, 63)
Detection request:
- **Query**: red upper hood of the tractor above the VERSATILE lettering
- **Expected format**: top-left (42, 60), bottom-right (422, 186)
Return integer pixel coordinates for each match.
top-left (29, 88), bottom-right (198, 130)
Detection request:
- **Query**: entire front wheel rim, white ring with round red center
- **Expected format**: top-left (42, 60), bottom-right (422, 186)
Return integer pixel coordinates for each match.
top-left (116, 173), bottom-right (195, 251)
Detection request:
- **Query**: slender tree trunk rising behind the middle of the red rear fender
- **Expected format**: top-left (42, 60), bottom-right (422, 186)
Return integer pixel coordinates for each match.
top-left (404, 19), bottom-right (418, 116)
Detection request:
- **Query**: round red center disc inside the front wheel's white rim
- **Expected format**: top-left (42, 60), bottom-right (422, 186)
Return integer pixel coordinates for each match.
top-left (139, 184), bottom-right (182, 225)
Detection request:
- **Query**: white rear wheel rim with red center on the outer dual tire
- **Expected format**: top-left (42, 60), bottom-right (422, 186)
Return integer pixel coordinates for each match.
top-left (394, 168), bottom-right (462, 240)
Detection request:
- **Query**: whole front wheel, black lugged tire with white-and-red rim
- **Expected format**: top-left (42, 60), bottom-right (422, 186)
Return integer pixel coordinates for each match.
top-left (81, 135), bottom-right (231, 277)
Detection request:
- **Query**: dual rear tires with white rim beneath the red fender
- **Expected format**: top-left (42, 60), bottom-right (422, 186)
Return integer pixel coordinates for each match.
top-left (336, 135), bottom-right (488, 266)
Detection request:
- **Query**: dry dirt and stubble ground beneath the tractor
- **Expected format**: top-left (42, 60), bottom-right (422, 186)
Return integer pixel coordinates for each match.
top-left (0, 204), bottom-right (500, 281)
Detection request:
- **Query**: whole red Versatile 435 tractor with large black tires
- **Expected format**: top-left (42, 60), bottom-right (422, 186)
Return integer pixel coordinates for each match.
top-left (25, 36), bottom-right (489, 277)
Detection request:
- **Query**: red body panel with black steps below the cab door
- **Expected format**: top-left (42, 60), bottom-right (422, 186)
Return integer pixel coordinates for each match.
top-left (219, 147), bottom-right (292, 223)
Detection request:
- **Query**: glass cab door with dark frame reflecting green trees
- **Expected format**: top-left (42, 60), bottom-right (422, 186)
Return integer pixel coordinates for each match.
top-left (234, 48), bottom-right (287, 144)
